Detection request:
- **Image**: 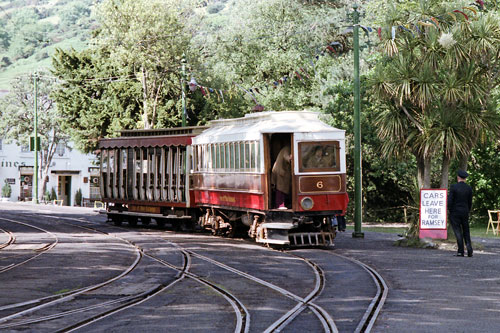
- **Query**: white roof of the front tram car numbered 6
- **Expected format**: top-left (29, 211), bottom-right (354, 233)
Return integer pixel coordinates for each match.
top-left (193, 111), bottom-right (345, 144)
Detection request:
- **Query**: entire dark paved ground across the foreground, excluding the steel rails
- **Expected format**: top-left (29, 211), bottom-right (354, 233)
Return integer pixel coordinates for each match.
top-left (0, 204), bottom-right (500, 332)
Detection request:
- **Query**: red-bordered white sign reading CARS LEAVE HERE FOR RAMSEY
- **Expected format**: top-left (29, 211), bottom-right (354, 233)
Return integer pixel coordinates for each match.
top-left (419, 189), bottom-right (448, 239)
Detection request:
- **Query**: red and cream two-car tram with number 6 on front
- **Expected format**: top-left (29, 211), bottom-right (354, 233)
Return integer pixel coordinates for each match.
top-left (99, 111), bottom-right (348, 246)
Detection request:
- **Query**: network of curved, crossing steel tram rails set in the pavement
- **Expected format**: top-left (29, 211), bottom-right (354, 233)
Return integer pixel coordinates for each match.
top-left (0, 209), bottom-right (387, 332)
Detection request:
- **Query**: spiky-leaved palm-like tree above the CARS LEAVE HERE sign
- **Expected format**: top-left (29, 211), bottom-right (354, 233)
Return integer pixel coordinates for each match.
top-left (371, 1), bottom-right (500, 188)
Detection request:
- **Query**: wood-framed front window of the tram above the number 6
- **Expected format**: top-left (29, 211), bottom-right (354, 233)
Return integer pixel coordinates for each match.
top-left (299, 141), bottom-right (340, 172)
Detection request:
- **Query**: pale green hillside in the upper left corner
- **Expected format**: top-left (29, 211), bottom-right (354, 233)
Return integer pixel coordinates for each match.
top-left (0, 0), bottom-right (96, 91)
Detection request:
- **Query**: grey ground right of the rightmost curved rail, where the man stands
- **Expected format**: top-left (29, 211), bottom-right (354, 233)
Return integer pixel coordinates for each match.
top-left (335, 228), bottom-right (500, 332)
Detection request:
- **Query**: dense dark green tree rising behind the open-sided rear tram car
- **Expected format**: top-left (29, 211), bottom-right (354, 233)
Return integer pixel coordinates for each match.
top-left (51, 48), bottom-right (141, 152)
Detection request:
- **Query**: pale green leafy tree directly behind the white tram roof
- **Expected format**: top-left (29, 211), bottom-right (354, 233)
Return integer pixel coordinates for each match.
top-left (193, 0), bottom-right (345, 112)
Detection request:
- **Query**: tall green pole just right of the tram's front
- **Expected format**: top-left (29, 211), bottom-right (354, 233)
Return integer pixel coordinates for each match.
top-left (352, 4), bottom-right (364, 238)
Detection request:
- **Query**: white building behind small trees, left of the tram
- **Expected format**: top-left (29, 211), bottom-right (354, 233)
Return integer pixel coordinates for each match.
top-left (0, 139), bottom-right (100, 206)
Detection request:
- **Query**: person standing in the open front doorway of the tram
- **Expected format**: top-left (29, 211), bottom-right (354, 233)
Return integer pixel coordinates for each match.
top-left (271, 146), bottom-right (292, 209)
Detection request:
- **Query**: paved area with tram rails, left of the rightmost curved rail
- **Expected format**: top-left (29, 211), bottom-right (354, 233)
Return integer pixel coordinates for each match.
top-left (0, 205), bottom-right (376, 332)
